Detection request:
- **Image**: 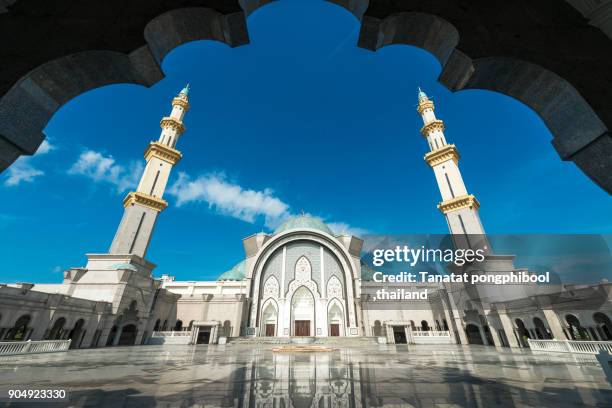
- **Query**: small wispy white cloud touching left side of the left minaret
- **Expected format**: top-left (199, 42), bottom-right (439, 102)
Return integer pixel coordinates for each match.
top-left (68, 150), bottom-right (144, 193)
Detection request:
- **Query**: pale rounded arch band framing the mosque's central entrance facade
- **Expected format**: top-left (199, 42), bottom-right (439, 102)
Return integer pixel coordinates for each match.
top-left (247, 228), bottom-right (358, 328)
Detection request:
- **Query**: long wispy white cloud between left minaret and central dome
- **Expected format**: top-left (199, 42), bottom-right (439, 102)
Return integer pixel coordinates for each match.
top-left (168, 172), bottom-right (289, 226)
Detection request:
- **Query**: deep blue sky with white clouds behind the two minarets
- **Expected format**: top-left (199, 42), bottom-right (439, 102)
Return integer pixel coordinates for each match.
top-left (0, 0), bottom-right (612, 282)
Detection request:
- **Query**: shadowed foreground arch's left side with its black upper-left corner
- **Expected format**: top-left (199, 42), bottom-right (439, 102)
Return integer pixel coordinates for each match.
top-left (0, 0), bottom-right (260, 171)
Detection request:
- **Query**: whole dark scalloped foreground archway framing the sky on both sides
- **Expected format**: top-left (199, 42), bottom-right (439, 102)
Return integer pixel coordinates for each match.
top-left (0, 0), bottom-right (612, 192)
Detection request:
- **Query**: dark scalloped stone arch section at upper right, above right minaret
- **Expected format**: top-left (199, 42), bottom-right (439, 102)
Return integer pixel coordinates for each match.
top-left (359, 7), bottom-right (612, 192)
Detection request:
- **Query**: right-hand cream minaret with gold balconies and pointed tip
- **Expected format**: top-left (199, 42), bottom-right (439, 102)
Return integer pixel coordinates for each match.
top-left (417, 88), bottom-right (487, 249)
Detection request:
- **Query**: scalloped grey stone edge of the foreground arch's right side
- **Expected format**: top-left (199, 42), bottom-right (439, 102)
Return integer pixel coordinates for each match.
top-left (350, 7), bottom-right (612, 192)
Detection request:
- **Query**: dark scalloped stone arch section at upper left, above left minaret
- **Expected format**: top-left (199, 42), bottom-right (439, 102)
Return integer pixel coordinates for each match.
top-left (0, 0), bottom-right (260, 171)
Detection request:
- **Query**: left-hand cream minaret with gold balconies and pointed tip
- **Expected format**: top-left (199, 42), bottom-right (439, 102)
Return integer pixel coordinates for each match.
top-left (109, 85), bottom-right (189, 258)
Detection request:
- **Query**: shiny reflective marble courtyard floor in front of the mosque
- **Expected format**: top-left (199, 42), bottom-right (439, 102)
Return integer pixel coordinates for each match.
top-left (0, 345), bottom-right (612, 408)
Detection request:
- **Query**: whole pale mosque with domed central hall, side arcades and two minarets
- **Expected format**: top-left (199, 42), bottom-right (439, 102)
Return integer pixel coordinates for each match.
top-left (0, 86), bottom-right (612, 348)
